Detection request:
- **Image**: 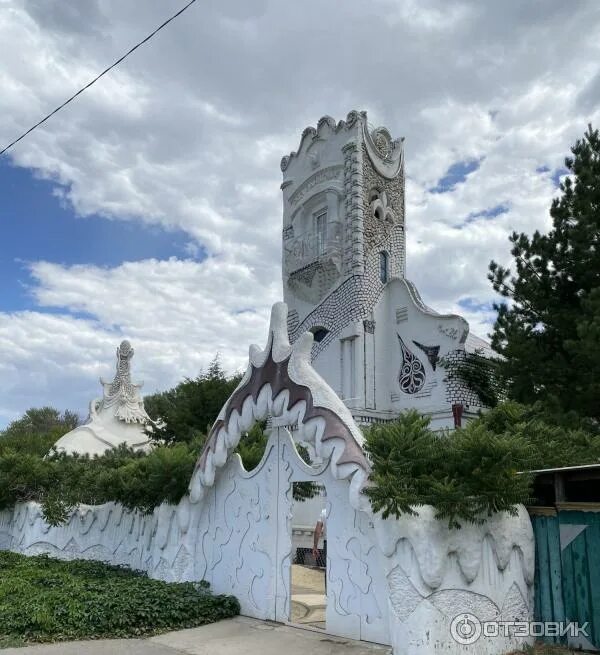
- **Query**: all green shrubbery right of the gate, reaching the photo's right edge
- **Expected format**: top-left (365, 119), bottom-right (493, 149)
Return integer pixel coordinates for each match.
top-left (365, 402), bottom-right (600, 527)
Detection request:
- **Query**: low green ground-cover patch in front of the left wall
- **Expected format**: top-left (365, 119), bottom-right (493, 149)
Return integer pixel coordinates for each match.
top-left (0, 552), bottom-right (240, 647)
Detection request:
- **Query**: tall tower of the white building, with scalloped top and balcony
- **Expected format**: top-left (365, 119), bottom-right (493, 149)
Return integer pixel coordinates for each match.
top-left (281, 111), bottom-right (405, 349)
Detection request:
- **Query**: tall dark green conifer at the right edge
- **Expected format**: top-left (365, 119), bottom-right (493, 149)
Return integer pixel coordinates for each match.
top-left (488, 126), bottom-right (600, 420)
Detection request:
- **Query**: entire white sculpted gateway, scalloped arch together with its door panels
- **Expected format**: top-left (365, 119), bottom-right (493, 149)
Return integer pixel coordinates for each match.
top-left (190, 303), bottom-right (389, 643)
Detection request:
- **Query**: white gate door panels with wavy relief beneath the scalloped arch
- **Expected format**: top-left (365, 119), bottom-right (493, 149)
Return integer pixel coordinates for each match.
top-left (196, 428), bottom-right (389, 643)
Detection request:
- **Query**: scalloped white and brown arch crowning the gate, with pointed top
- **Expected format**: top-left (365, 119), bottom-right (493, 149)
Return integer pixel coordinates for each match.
top-left (190, 303), bottom-right (369, 509)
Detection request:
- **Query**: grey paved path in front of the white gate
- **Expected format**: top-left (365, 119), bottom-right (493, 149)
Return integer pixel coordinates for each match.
top-left (1, 616), bottom-right (391, 655)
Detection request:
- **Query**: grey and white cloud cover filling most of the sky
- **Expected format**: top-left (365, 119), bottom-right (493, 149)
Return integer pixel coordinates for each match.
top-left (0, 0), bottom-right (600, 421)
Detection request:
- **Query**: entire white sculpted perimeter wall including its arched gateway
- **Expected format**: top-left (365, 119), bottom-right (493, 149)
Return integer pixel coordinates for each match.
top-left (0, 303), bottom-right (534, 655)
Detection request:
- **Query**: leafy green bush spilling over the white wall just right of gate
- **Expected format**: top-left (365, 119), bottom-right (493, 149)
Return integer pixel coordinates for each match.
top-left (365, 410), bottom-right (535, 528)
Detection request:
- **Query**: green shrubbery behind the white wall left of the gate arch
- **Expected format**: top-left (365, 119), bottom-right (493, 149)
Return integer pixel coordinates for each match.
top-left (0, 360), bottom-right (316, 525)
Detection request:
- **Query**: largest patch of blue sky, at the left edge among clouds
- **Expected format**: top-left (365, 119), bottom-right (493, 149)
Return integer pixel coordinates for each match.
top-left (0, 157), bottom-right (202, 312)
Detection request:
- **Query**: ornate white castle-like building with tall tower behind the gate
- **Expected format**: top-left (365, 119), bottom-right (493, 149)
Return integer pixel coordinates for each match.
top-left (281, 111), bottom-right (489, 428)
